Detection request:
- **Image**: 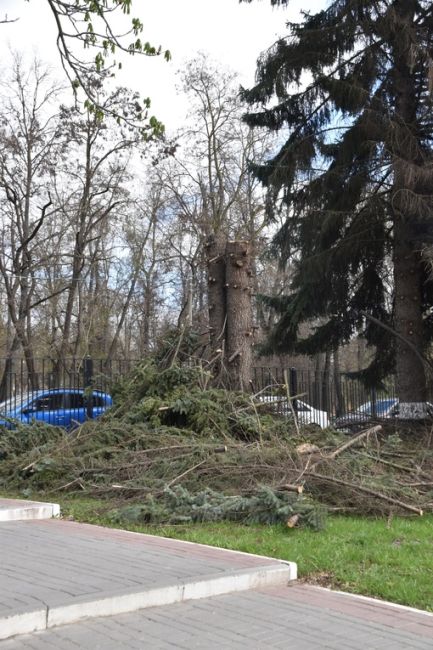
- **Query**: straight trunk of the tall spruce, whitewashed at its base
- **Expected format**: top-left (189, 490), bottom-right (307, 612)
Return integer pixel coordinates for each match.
top-left (391, 0), bottom-right (426, 412)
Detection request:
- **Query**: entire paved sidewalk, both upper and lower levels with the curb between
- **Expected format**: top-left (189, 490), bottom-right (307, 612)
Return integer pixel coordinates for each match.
top-left (0, 500), bottom-right (433, 650)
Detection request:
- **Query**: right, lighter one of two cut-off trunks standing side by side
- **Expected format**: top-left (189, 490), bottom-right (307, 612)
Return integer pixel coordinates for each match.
top-left (225, 241), bottom-right (253, 391)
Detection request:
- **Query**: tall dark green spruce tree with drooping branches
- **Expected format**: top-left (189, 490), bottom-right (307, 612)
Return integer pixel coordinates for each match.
top-left (243, 0), bottom-right (433, 417)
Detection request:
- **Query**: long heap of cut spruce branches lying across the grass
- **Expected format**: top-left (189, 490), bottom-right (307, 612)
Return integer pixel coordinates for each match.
top-left (0, 360), bottom-right (433, 526)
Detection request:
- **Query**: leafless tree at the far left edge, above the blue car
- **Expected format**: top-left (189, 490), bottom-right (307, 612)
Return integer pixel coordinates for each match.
top-left (0, 56), bottom-right (63, 382)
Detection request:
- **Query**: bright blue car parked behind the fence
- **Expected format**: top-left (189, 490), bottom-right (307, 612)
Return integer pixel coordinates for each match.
top-left (0, 388), bottom-right (113, 429)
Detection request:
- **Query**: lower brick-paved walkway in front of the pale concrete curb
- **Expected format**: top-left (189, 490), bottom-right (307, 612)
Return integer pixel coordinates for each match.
top-left (0, 584), bottom-right (433, 650)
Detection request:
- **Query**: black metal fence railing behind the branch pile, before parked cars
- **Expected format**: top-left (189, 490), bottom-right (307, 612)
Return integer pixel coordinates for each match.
top-left (0, 357), bottom-right (412, 426)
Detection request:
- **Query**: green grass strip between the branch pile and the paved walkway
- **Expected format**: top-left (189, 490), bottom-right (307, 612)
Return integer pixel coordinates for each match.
top-left (51, 497), bottom-right (433, 611)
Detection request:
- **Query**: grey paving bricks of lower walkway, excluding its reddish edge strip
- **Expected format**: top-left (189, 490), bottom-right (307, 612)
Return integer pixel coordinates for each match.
top-left (5, 588), bottom-right (426, 650)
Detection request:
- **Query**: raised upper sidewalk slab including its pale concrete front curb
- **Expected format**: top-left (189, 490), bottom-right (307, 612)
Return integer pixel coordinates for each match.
top-left (0, 506), bottom-right (296, 639)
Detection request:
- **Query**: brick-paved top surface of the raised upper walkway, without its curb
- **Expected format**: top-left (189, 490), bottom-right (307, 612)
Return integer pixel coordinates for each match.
top-left (0, 520), bottom-right (292, 638)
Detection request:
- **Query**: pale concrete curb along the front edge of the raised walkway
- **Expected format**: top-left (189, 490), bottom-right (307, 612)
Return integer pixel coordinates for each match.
top-left (0, 562), bottom-right (297, 639)
